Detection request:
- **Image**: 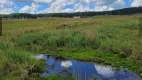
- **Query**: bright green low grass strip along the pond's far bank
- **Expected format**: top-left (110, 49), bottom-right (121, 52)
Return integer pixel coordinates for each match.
top-left (57, 50), bottom-right (140, 72)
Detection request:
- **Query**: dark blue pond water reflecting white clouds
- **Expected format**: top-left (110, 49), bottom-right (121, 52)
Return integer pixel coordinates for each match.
top-left (37, 55), bottom-right (141, 80)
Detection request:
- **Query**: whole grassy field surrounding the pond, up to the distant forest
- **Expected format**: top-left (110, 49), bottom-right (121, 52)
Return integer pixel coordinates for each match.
top-left (0, 15), bottom-right (142, 80)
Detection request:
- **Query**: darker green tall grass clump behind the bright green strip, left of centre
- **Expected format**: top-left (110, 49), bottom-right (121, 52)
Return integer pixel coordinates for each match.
top-left (15, 30), bottom-right (96, 50)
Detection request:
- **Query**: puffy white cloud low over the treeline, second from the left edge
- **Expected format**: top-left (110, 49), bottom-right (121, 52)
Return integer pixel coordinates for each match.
top-left (19, 3), bottom-right (38, 14)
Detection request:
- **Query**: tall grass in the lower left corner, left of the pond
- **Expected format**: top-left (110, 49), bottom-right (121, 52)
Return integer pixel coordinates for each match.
top-left (0, 41), bottom-right (43, 80)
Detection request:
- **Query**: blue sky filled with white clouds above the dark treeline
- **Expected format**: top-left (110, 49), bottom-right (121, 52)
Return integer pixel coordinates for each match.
top-left (0, 0), bottom-right (142, 14)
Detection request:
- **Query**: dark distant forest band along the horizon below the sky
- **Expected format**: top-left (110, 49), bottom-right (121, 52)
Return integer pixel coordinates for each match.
top-left (1, 7), bottom-right (142, 19)
